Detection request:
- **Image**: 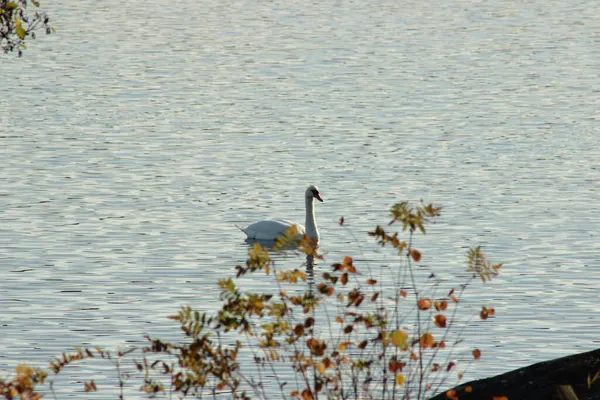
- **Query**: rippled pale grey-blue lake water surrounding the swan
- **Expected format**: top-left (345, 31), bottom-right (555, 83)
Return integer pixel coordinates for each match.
top-left (0, 0), bottom-right (600, 398)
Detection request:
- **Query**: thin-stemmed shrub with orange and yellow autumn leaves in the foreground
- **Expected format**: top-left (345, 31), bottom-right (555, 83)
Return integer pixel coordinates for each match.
top-left (4, 202), bottom-right (500, 400)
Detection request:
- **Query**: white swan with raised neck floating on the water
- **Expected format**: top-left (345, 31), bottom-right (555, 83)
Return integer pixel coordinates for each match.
top-left (238, 185), bottom-right (323, 240)
